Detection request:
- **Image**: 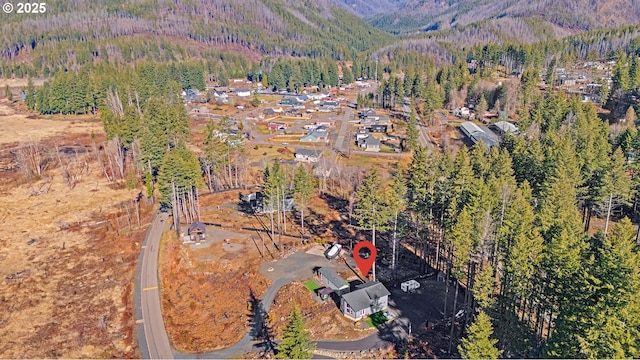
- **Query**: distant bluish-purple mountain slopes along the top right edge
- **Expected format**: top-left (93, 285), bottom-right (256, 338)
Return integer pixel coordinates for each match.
top-left (336, 0), bottom-right (640, 41)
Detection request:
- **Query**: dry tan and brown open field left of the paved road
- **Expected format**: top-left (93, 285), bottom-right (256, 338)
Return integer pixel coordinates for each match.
top-left (0, 100), bottom-right (151, 358)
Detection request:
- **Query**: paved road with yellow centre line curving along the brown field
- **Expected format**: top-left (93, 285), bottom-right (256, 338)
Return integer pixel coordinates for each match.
top-left (136, 213), bottom-right (173, 359)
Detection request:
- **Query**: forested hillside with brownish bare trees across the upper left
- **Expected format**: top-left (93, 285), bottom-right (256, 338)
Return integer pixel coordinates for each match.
top-left (0, 0), bottom-right (392, 77)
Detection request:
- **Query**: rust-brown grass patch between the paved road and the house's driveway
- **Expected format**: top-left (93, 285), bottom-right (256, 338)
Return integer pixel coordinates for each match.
top-left (161, 233), bottom-right (269, 352)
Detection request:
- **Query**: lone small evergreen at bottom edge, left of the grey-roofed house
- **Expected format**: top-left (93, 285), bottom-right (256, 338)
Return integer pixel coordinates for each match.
top-left (276, 304), bottom-right (316, 359)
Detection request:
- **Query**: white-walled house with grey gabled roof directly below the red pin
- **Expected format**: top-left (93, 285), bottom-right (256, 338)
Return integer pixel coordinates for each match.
top-left (340, 281), bottom-right (391, 320)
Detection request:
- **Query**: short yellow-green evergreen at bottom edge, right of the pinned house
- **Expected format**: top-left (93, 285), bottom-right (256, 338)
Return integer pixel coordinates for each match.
top-left (458, 311), bottom-right (502, 359)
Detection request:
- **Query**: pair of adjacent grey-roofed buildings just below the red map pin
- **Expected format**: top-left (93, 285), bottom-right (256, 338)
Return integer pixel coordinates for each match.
top-left (317, 267), bottom-right (391, 320)
